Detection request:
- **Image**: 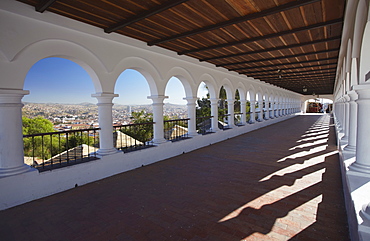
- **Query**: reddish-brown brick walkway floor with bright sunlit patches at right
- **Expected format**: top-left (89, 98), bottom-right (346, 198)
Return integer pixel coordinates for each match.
top-left (0, 115), bottom-right (349, 241)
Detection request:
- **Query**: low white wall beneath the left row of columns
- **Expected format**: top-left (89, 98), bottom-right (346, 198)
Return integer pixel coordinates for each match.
top-left (0, 115), bottom-right (296, 210)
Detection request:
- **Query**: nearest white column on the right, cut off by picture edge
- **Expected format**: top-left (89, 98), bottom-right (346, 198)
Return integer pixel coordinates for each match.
top-left (349, 84), bottom-right (370, 174)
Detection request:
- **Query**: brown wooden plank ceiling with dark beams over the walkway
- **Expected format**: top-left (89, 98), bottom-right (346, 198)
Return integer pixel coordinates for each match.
top-left (19, 0), bottom-right (345, 95)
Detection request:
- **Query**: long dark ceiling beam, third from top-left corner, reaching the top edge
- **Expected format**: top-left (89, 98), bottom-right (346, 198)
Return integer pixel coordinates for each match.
top-left (148, 0), bottom-right (321, 46)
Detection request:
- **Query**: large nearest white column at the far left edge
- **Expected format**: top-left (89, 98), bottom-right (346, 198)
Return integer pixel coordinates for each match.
top-left (0, 89), bottom-right (32, 177)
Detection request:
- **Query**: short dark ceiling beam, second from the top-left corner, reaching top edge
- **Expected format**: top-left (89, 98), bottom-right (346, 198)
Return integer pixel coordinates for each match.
top-left (104, 0), bottom-right (188, 33)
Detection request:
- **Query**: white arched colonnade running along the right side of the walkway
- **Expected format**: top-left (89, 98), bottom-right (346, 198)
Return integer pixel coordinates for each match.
top-left (334, 0), bottom-right (370, 240)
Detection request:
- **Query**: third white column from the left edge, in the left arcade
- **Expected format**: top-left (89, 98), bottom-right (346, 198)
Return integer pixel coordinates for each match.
top-left (148, 95), bottom-right (168, 144)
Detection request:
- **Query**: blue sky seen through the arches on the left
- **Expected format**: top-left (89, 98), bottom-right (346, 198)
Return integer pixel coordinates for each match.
top-left (23, 58), bottom-right (205, 105)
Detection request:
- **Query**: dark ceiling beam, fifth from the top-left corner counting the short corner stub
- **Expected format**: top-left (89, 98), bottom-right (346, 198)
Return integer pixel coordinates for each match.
top-left (199, 36), bottom-right (341, 62)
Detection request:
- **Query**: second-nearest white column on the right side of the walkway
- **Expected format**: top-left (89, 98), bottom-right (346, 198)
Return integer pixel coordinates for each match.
top-left (344, 90), bottom-right (357, 153)
